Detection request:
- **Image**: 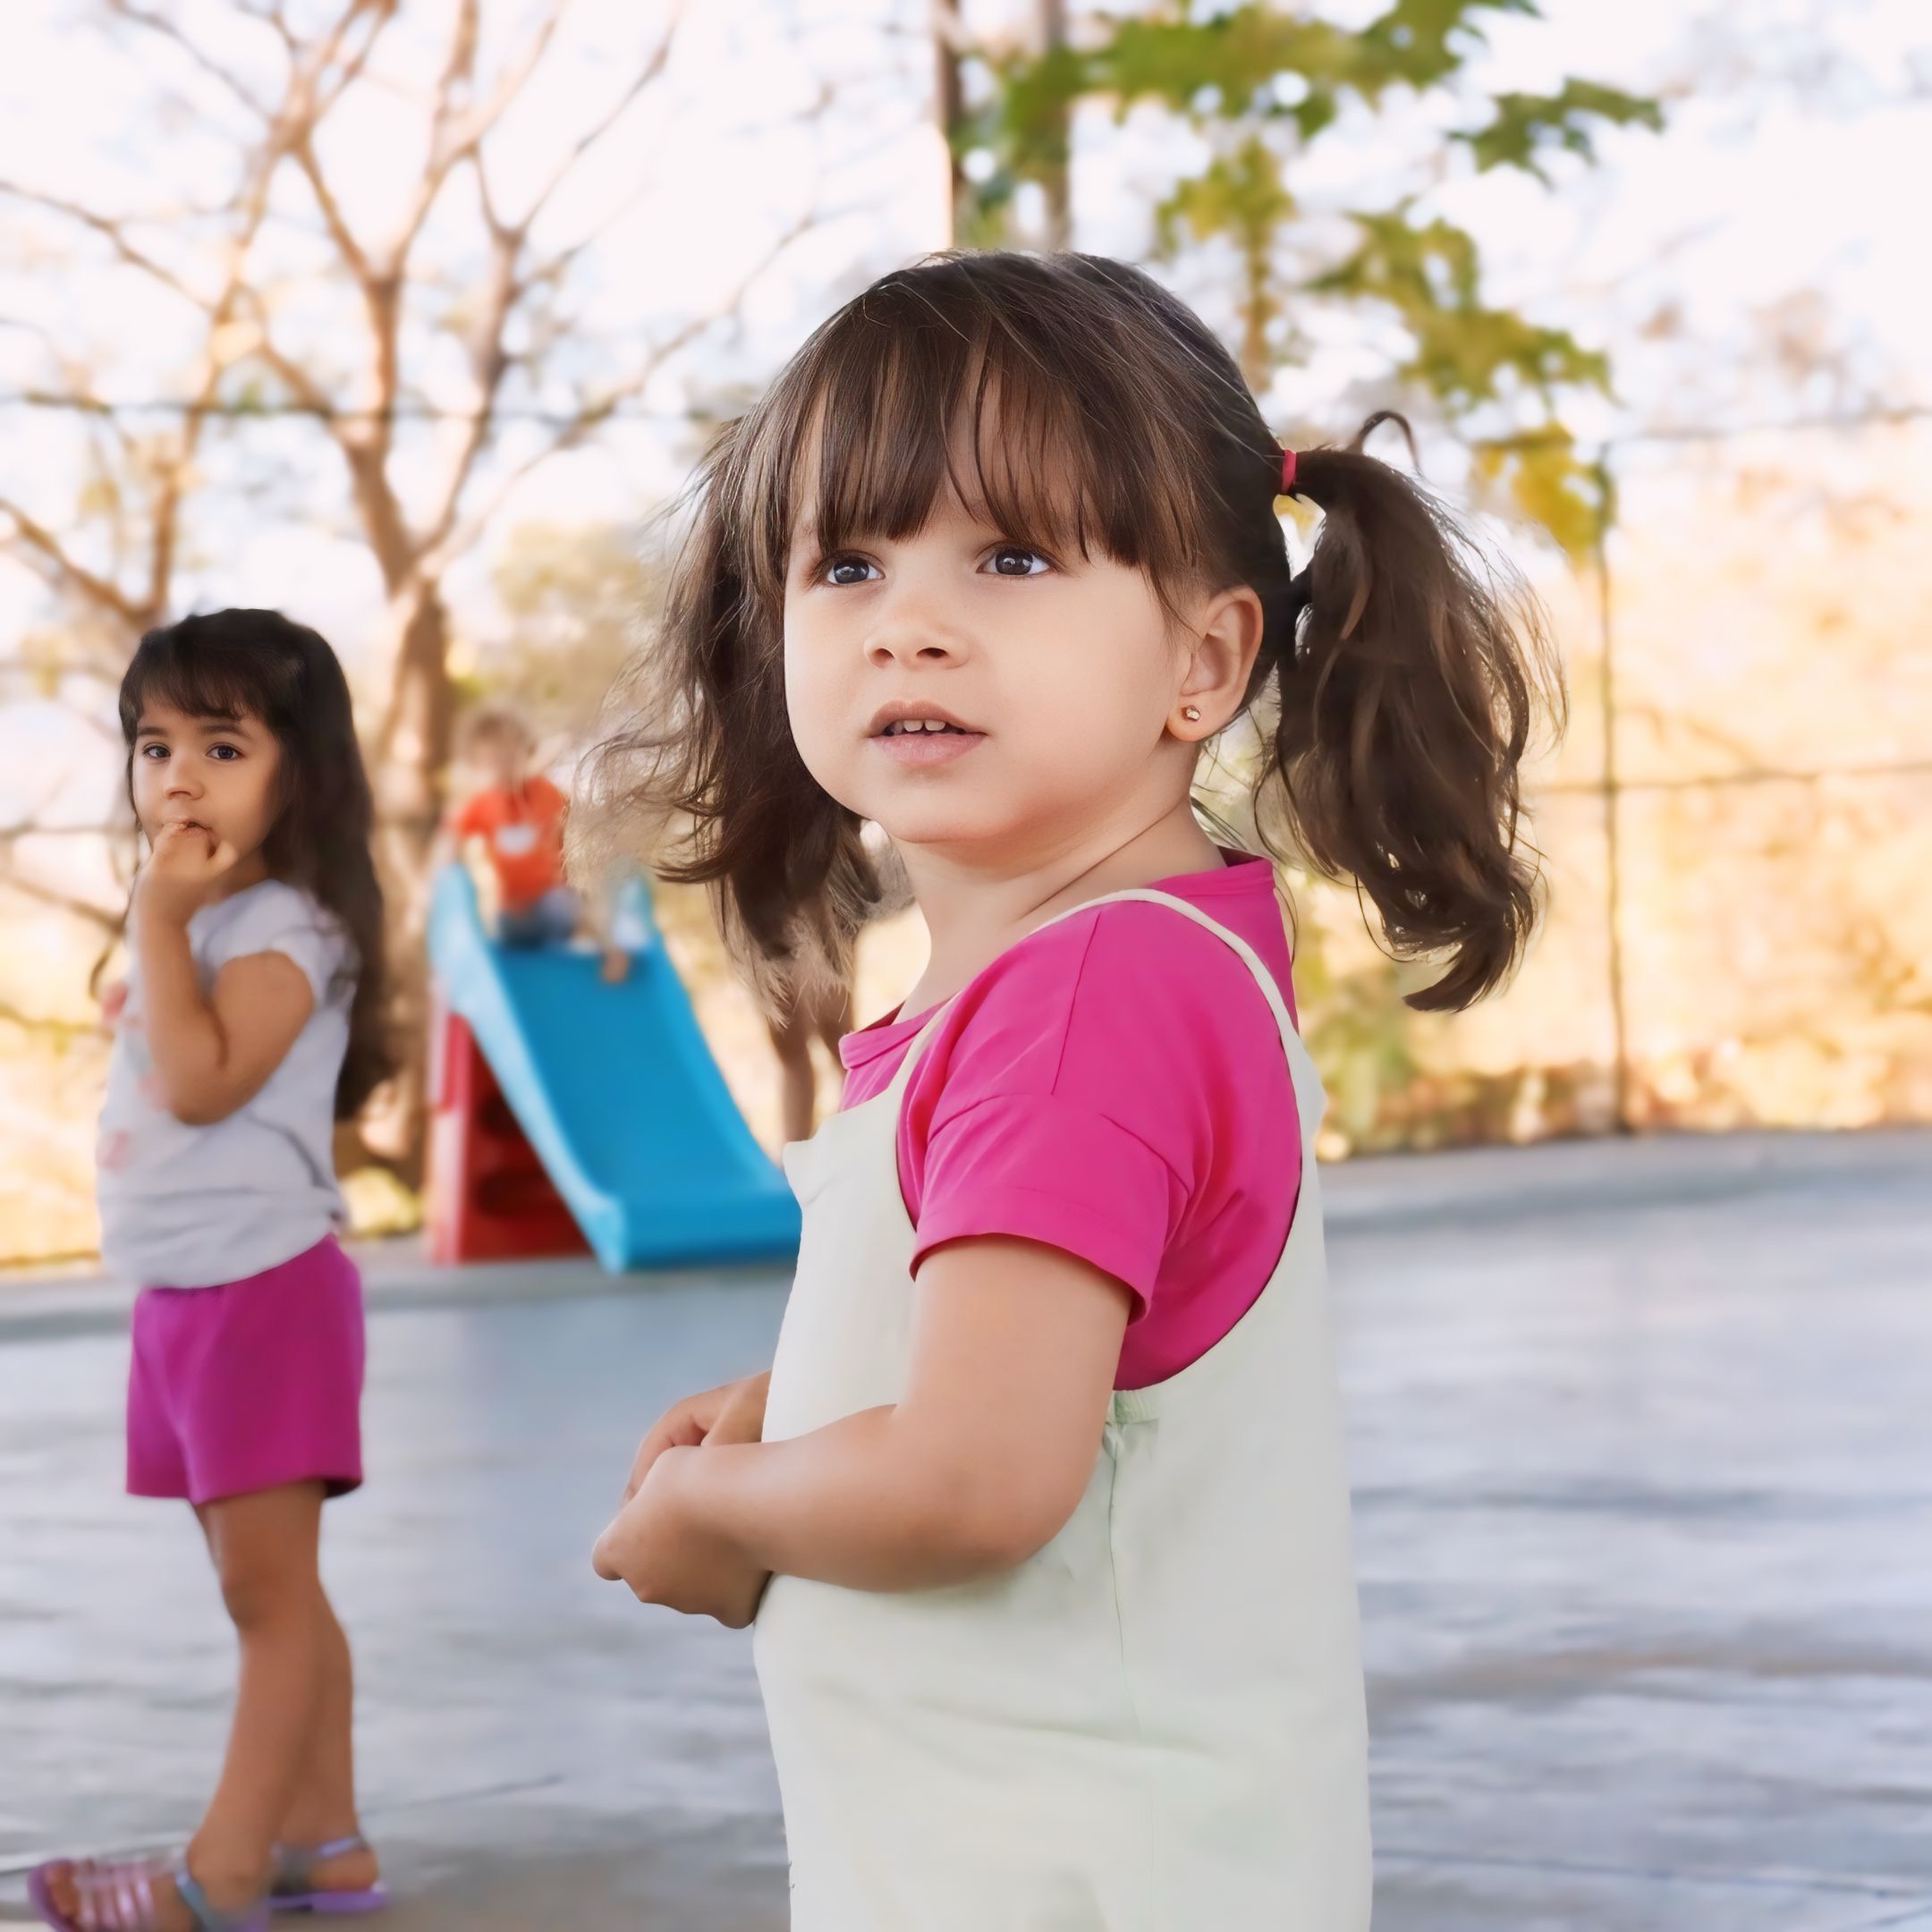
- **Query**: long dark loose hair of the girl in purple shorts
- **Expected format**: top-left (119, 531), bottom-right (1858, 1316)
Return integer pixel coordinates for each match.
top-left (120, 611), bottom-right (392, 1121)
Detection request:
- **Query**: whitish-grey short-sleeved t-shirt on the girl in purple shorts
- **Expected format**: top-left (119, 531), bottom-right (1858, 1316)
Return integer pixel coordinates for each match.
top-left (95, 879), bottom-right (353, 1289)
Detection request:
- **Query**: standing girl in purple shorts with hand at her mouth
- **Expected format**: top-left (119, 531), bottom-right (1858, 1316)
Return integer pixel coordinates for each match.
top-left (29, 611), bottom-right (386, 1932)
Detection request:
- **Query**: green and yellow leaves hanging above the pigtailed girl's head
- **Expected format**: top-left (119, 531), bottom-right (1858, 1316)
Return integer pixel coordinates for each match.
top-left (953, 0), bottom-right (1662, 551)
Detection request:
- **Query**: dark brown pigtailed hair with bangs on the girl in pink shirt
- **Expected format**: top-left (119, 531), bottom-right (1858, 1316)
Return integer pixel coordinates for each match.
top-left (578, 253), bottom-right (1559, 1009)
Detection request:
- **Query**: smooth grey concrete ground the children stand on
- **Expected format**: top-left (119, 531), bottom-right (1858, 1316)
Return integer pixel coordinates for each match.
top-left (0, 1134), bottom-right (1932, 1932)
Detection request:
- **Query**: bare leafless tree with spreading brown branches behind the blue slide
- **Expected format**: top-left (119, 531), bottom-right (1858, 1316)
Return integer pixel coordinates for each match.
top-left (0, 0), bottom-right (858, 1174)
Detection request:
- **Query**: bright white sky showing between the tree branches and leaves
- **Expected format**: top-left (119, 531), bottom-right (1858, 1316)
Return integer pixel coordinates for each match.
top-left (0, 0), bottom-right (1932, 846)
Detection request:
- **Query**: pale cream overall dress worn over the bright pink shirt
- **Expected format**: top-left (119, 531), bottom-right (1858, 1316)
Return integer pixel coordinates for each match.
top-left (753, 893), bottom-right (1369, 1932)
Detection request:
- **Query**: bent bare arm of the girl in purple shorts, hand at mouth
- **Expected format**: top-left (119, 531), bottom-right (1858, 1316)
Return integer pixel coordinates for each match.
top-left (133, 829), bottom-right (315, 1126)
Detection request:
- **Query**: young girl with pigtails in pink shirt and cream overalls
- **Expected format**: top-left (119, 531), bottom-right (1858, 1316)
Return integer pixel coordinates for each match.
top-left (591, 253), bottom-right (1546, 1932)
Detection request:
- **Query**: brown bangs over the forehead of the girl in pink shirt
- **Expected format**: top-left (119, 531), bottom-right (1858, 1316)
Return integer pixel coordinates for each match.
top-left (733, 261), bottom-right (1204, 608)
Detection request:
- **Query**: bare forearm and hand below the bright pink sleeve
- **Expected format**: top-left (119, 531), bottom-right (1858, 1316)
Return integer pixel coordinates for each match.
top-left (597, 1236), bottom-right (1128, 1621)
